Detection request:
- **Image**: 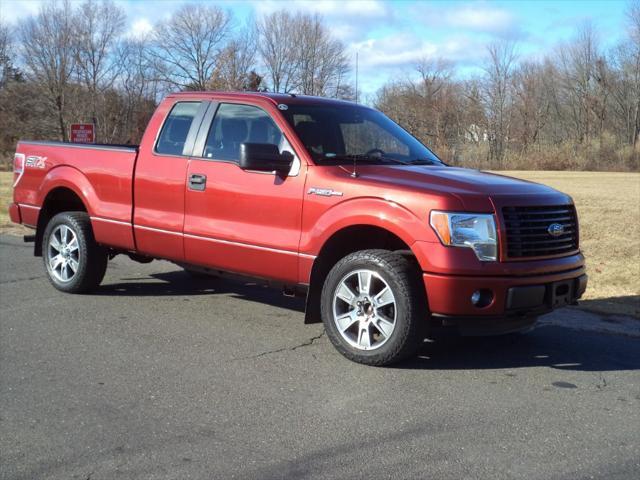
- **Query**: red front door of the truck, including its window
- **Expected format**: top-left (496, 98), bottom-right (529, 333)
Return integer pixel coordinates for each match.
top-left (184, 103), bottom-right (305, 283)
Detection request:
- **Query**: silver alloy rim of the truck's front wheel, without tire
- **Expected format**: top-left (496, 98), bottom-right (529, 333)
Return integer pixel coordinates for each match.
top-left (333, 270), bottom-right (397, 350)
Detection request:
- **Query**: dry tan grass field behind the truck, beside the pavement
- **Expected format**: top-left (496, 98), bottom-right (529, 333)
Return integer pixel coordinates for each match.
top-left (0, 171), bottom-right (640, 317)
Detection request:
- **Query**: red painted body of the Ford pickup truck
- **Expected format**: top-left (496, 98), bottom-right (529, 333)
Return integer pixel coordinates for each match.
top-left (9, 92), bottom-right (584, 315)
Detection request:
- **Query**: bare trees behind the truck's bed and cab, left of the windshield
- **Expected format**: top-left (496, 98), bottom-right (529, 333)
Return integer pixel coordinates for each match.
top-left (0, 0), bottom-right (350, 157)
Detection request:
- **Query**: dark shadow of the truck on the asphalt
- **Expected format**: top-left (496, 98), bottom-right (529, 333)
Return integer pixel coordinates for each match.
top-left (95, 270), bottom-right (640, 372)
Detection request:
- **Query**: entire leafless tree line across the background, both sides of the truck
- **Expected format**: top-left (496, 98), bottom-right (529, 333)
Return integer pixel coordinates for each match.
top-left (0, 0), bottom-right (640, 170)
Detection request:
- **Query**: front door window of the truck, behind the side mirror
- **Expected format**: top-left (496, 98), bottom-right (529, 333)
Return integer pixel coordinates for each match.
top-left (203, 103), bottom-right (284, 162)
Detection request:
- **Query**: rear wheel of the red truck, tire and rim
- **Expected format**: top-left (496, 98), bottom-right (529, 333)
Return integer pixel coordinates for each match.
top-left (42, 212), bottom-right (108, 293)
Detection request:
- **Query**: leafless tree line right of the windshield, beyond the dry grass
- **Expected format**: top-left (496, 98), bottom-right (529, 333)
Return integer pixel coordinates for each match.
top-left (374, 6), bottom-right (640, 170)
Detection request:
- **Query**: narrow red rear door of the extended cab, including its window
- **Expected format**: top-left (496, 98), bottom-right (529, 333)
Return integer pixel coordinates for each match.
top-left (133, 100), bottom-right (210, 261)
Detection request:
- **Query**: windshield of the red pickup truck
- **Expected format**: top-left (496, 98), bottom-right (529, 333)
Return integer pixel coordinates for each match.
top-left (282, 105), bottom-right (443, 165)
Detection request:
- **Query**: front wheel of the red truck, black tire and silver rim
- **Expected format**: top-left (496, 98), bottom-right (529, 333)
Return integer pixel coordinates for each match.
top-left (321, 250), bottom-right (427, 365)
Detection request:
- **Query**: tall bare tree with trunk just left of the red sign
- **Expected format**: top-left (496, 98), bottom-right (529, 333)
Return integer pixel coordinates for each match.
top-left (19, 0), bottom-right (76, 140)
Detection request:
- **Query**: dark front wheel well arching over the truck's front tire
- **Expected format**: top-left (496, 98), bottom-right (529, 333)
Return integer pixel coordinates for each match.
top-left (304, 225), bottom-right (417, 323)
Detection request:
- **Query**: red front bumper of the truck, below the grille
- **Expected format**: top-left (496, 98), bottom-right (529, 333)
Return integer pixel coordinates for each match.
top-left (423, 267), bottom-right (587, 333)
